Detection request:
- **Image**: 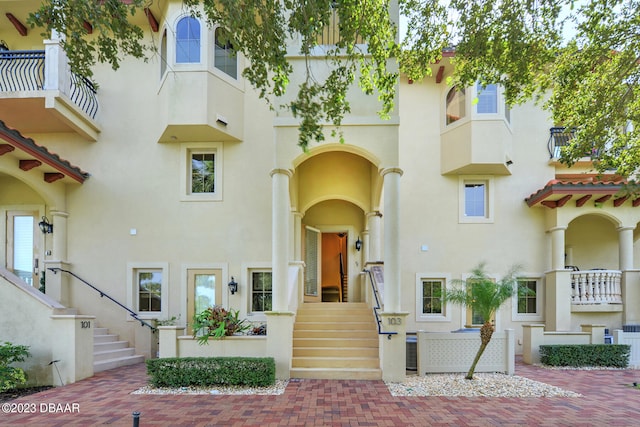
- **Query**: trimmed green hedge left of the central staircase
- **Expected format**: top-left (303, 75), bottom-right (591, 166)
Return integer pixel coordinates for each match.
top-left (146, 357), bottom-right (276, 387)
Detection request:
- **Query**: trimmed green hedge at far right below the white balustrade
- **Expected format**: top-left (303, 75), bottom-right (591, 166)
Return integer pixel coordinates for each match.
top-left (540, 344), bottom-right (631, 368)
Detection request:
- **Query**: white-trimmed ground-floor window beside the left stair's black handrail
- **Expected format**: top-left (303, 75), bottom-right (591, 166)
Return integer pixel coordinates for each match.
top-left (127, 263), bottom-right (169, 319)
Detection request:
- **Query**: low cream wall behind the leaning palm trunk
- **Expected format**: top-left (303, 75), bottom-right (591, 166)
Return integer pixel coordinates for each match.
top-left (417, 329), bottom-right (515, 375)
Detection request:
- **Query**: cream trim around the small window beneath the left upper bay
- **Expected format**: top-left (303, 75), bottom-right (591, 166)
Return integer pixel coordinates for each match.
top-left (180, 142), bottom-right (224, 202)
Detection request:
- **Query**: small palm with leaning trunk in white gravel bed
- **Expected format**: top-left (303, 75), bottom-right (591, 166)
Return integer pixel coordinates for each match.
top-left (444, 263), bottom-right (528, 380)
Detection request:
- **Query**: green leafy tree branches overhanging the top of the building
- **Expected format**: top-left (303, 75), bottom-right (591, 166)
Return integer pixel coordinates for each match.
top-left (23, 0), bottom-right (640, 172)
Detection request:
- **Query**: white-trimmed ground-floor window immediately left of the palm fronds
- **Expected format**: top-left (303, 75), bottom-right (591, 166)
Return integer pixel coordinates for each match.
top-left (416, 272), bottom-right (451, 322)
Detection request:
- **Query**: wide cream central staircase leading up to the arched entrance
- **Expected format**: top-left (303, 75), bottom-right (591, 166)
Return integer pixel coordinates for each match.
top-left (290, 303), bottom-right (382, 380)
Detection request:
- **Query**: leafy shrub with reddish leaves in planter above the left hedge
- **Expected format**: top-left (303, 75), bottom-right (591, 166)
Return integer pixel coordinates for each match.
top-left (191, 305), bottom-right (251, 345)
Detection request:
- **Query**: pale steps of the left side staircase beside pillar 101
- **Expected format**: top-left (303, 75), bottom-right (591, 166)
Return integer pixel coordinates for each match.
top-left (93, 327), bottom-right (144, 372)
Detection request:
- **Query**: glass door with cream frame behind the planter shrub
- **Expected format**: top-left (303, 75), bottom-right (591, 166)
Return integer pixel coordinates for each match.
top-left (186, 268), bottom-right (222, 334)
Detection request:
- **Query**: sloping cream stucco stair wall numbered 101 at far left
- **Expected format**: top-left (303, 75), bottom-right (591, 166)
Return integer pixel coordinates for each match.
top-left (0, 269), bottom-right (95, 385)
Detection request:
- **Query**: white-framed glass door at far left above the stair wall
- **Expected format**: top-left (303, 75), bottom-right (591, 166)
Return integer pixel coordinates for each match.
top-left (6, 211), bottom-right (40, 286)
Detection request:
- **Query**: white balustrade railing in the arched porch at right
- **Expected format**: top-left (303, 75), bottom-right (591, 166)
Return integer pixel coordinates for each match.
top-left (571, 270), bottom-right (622, 304)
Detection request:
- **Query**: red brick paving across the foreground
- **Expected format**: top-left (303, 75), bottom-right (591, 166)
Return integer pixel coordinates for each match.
top-left (0, 362), bottom-right (640, 427)
